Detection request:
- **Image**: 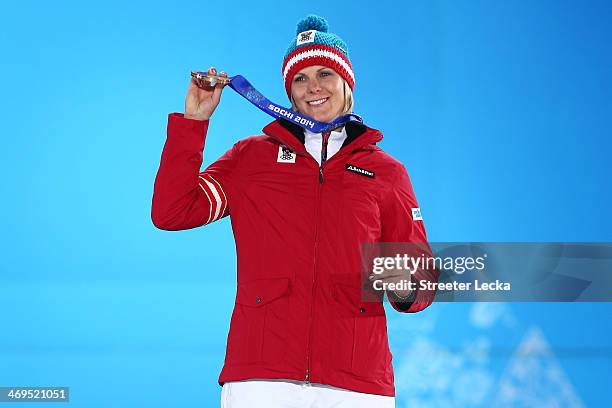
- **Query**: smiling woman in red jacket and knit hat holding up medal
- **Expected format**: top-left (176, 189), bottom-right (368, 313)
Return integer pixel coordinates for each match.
top-left (152, 16), bottom-right (437, 408)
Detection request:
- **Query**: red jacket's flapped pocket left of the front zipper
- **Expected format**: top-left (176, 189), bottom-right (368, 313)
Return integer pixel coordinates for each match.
top-left (226, 278), bottom-right (289, 364)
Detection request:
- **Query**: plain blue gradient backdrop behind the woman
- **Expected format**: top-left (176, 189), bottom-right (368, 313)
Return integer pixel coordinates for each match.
top-left (0, 1), bottom-right (612, 408)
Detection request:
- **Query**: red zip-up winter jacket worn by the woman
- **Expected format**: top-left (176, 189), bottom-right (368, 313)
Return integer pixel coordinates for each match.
top-left (151, 113), bottom-right (438, 396)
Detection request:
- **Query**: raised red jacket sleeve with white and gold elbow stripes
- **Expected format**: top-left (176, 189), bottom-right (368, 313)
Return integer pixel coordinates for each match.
top-left (151, 113), bottom-right (237, 231)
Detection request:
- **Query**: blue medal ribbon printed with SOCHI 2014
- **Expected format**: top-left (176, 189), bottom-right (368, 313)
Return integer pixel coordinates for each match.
top-left (229, 75), bottom-right (363, 133)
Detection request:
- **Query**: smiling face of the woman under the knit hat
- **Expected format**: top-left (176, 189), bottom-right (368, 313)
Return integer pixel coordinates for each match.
top-left (291, 65), bottom-right (344, 122)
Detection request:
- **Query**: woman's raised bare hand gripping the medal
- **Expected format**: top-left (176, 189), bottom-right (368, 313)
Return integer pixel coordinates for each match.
top-left (184, 67), bottom-right (227, 120)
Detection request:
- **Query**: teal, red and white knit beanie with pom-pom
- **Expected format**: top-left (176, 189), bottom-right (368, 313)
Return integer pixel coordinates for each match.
top-left (283, 14), bottom-right (355, 99)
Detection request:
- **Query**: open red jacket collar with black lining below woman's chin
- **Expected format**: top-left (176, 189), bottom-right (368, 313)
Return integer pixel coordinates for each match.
top-left (263, 118), bottom-right (382, 154)
